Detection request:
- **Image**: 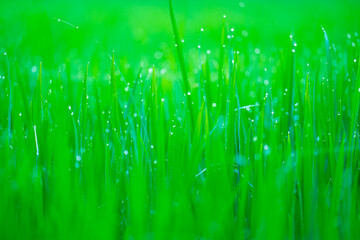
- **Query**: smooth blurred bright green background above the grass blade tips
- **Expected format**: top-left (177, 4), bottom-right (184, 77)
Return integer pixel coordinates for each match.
top-left (0, 0), bottom-right (360, 67)
